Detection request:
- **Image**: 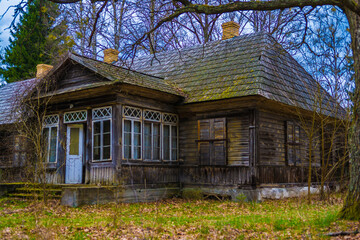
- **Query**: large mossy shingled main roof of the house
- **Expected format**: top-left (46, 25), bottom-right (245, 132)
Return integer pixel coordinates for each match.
top-left (133, 32), bottom-right (337, 113)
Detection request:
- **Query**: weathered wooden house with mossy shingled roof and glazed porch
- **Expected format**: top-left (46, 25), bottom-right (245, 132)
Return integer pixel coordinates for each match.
top-left (0, 22), bottom-right (343, 203)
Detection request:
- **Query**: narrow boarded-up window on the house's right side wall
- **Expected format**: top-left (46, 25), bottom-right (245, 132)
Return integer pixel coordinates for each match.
top-left (286, 121), bottom-right (301, 166)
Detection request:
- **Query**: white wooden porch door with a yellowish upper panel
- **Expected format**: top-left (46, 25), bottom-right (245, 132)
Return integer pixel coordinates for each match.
top-left (65, 124), bottom-right (84, 183)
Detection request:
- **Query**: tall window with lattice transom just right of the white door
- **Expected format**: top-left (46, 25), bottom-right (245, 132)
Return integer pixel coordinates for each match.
top-left (92, 107), bottom-right (112, 161)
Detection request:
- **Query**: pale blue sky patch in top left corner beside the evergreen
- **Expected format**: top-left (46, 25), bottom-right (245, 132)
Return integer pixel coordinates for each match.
top-left (0, 0), bottom-right (20, 47)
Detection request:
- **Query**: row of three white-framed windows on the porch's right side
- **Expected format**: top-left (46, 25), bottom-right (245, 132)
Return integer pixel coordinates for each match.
top-left (123, 106), bottom-right (178, 161)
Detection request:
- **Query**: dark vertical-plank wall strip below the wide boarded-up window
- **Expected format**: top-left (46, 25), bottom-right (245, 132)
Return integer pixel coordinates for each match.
top-left (181, 166), bottom-right (252, 187)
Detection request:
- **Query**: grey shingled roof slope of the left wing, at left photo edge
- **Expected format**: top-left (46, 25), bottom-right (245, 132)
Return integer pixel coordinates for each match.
top-left (0, 78), bottom-right (36, 125)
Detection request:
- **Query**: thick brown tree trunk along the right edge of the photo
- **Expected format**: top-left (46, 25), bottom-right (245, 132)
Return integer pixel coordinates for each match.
top-left (340, 10), bottom-right (360, 220)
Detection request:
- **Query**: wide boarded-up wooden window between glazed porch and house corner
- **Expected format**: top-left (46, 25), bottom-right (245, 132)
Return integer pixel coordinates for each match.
top-left (198, 118), bottom-right (226, 165)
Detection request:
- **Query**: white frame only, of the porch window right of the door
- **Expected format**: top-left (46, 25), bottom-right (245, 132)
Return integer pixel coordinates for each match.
top-left (91, 106), bottom-right (113, 162)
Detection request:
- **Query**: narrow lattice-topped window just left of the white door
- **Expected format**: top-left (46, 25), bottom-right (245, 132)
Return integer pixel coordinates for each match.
top-left (43, 115), bottom-right (59, 163)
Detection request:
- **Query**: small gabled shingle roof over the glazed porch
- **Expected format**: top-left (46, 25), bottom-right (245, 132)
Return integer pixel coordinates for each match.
top-left (49, 53), bottom-right (182, 95)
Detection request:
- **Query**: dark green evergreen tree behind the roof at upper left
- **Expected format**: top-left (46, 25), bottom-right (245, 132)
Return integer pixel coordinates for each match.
top-left (0, 0), bottom-right (73, 82)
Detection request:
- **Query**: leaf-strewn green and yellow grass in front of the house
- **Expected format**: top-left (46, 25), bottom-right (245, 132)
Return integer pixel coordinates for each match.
top-left (0, 196), bottom-right (360, 239)
